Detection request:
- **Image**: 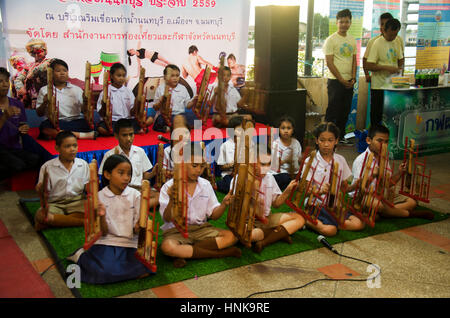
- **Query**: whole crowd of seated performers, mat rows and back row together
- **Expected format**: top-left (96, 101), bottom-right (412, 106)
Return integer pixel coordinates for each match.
top-left (0, 49), bottom-right (433, 284)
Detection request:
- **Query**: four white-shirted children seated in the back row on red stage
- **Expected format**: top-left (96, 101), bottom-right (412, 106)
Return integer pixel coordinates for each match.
top-left (31, 59), bottom-right (250, 139)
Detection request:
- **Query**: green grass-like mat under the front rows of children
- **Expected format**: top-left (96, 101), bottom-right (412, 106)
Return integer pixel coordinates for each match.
top-left (20, 193), bottom-right (448, 298)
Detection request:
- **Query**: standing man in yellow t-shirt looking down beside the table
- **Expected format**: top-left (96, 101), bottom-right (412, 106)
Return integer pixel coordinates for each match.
top-left (366, 19), bottom-right (405, 126)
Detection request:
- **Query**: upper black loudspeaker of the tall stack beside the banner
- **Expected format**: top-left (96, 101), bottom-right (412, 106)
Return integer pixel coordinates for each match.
top-left (255, 6), bottom-right (300, 90)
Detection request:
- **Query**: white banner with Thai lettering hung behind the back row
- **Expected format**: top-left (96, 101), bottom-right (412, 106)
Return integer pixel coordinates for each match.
top-left (1, 0), bottom-right (250, 100)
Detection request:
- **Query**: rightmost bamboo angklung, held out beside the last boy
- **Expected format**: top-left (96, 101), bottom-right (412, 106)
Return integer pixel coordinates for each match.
top-left (399, 137), bottom-right (431, 203)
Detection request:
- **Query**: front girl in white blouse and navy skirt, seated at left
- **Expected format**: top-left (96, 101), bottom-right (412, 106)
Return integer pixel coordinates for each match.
top-left (67, 155), bottom-right (151, 284)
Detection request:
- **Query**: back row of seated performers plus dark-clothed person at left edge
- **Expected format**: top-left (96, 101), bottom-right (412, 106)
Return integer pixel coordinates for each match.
top-left (0, 58), bottom-right (245, 184)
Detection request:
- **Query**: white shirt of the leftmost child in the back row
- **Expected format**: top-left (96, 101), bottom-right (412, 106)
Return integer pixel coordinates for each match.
top-left (36, 82), bottom-right (83, 121)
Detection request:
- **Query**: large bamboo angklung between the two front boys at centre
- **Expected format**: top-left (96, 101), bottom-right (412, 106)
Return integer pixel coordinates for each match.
top-left (226, 125), bottom-right (263, 248)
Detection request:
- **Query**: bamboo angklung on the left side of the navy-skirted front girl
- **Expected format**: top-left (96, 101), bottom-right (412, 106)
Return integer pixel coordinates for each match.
top-left (83, 159), bottom-right (102, 250)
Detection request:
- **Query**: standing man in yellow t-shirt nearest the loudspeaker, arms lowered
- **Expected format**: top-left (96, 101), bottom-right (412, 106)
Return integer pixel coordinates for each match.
top-left (323, 9), bottom-right (356, 141)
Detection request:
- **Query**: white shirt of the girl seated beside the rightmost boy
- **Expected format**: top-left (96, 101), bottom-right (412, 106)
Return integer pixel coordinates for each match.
top-left (303, 151), bottom-right (352, 199)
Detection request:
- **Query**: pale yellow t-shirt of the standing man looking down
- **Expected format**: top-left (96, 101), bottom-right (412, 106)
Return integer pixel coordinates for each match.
top-left (367, 36), bottom-right (403, 89)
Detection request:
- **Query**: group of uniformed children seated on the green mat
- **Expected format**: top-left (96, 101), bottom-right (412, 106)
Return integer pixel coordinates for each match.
top-left (31, 106), bottom-right (433, 284)
